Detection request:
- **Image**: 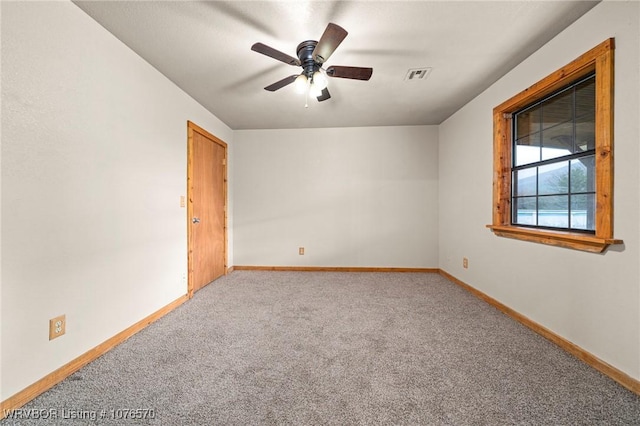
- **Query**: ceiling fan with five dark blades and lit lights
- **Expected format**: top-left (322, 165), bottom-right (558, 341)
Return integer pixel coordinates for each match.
top-left (251, 23), bottom-right (373, 102)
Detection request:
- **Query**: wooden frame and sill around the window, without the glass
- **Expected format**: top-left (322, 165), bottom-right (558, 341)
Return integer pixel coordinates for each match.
top-left (487, 38), bottom-right (623, 253)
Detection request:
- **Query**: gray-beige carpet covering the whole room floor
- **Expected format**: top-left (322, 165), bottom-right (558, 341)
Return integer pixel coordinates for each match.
top-left (0, 271), bottom-right (640, 426)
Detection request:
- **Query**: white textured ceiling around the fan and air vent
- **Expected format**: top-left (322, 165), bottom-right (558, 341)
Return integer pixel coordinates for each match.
top-left (74, 0), bottom-right (597, 129)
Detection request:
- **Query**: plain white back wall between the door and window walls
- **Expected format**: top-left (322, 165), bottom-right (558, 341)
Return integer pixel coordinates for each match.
top-left (233, 126), bottom-right (438, 267)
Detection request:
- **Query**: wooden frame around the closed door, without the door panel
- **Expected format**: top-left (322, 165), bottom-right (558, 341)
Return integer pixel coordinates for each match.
top-left (187, 121), bottom-right (228, 298)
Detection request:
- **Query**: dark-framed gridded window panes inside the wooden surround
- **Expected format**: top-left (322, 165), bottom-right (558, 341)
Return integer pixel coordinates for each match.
top-left (512, 75), bottom-right (596, 232)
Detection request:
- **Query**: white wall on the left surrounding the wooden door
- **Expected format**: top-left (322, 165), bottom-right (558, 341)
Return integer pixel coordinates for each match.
top-left (0, 2), bottom-right (233, 400)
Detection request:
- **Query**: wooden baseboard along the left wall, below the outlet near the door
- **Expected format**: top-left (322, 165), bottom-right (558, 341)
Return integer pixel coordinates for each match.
top-left (0, 295), bottom-right (189, 419)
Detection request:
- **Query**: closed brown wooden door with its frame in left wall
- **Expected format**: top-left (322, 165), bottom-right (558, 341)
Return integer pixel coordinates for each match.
top-left (187, 122), bottom-right (227, 297)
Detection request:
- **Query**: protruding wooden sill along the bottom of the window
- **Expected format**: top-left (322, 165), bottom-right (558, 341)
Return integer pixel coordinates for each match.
top-left (487, 225), bottom-right (623, 253)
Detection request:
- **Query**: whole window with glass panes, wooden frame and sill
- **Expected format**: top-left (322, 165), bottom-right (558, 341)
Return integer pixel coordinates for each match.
top-left (488, 39), bottom-right (622, 253)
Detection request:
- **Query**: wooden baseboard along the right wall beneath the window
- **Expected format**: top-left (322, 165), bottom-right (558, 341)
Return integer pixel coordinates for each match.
top-left (440, 269), bottom-right (640, 395)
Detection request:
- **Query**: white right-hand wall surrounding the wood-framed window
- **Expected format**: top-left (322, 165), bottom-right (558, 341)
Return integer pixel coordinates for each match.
top-left (439, 1), bottom-right (640, 379)
